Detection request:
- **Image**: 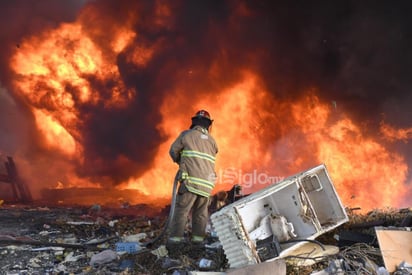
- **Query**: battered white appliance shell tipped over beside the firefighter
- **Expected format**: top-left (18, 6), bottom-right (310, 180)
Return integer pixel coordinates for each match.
top-left (211, 164), bottom-right (348, 267)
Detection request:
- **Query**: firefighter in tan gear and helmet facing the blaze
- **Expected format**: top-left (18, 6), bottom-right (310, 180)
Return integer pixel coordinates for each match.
top-left (167, 110), bottom-right (218, 248)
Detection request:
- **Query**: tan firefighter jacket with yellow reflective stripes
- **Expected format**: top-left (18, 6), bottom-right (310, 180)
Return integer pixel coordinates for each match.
top-left (170, 126), bottom-right (218, 197)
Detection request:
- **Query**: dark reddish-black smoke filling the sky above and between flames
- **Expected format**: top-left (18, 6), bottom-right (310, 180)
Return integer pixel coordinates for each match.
top-left (0, 0), bottom-right (412, 185)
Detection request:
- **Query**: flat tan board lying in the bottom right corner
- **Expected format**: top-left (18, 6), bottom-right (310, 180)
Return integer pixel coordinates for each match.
top-left (375, 227), bottom-right (412, 272)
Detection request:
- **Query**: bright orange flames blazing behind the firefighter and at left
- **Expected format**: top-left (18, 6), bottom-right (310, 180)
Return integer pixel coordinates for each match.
top-left (7, 2), bottom-right (411, 209)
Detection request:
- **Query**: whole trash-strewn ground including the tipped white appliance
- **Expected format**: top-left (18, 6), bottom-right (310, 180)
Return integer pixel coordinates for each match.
top-left (0, 165), bottom-right (412, 275)
